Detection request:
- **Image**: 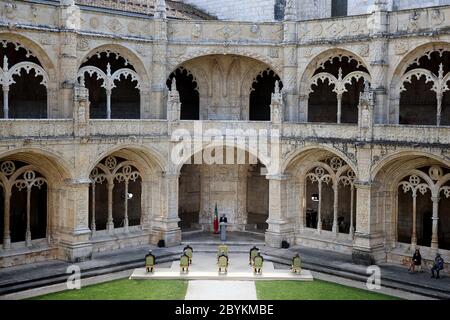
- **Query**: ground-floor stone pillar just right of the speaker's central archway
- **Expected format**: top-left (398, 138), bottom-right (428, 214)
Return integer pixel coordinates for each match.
top-left (266, 175), bottom-right (295, 248)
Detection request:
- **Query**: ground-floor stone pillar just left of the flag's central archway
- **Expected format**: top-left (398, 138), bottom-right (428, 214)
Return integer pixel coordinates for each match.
top-left (153, 172), bottom-right (181, 247)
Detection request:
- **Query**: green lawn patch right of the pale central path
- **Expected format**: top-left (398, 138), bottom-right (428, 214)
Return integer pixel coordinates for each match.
top-left (255, 280), bottom-right (398, 300)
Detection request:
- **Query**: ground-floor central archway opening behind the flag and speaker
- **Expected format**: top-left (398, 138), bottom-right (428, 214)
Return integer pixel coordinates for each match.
top-left (178, 149), bottom-right (269, 234)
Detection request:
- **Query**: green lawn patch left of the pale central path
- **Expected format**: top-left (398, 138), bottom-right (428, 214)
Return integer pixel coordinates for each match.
top-left (33, 279), bottom-right (188, 300)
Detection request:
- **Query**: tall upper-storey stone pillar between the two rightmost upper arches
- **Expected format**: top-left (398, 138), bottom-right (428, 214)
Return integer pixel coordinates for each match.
top-left (369, 0), bottom-right (389, 123)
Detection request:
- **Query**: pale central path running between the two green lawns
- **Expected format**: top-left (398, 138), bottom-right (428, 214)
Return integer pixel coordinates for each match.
top-left (185, 280), bottom-right (256, 300)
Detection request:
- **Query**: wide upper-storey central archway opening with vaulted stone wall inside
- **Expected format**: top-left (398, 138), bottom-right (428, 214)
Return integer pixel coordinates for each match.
top-left (167, 54), bottom-right (282, 121)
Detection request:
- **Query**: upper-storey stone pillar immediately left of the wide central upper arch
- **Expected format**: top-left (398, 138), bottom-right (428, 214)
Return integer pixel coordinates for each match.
top-left (151, 0), bottom-right (168, 119)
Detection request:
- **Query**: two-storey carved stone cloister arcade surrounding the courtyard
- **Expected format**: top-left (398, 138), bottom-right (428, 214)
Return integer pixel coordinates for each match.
top-left (0, 1), bottom-right (450, 267)
